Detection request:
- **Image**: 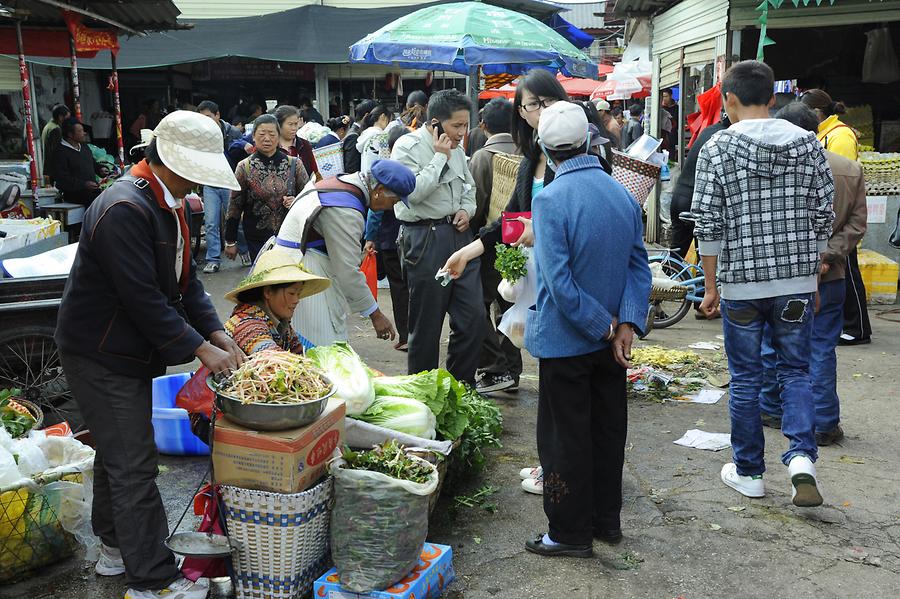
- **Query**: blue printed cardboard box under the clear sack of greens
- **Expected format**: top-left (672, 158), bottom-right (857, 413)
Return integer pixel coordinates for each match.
top-left (313, 543), bottom-right (456, 599)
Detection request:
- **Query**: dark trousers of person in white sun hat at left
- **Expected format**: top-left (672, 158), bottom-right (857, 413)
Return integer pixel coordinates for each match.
top-left (60, 353), bottom-right (178, 590)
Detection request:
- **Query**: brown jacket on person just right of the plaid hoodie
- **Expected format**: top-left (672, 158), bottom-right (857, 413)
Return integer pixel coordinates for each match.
top-left (822, 150), bottom-right (868, 283)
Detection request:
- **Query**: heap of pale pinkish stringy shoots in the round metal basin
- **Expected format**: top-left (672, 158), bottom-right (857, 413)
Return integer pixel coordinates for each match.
top-left (221, 350), bottom-right (331, 404)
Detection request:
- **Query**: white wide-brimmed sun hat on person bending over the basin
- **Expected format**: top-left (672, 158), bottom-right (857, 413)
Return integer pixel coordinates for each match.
top-left (153, 110), bottom-right (241, 191)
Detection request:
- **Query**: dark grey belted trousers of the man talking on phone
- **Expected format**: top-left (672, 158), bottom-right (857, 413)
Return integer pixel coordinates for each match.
top-left (398, 223), bottom-right (484, 384)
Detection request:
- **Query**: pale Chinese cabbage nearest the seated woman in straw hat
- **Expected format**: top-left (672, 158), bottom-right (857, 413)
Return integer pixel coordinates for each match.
top-left (306, 342), bottom-right (375, 416)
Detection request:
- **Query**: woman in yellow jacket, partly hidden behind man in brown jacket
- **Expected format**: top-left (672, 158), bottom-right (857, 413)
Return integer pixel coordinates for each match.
top-left (800, 89), bottom-right (872, 345)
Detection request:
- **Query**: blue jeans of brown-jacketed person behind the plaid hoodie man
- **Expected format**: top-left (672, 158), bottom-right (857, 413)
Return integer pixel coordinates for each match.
top-left (759, 280), bottom-right (847, 433)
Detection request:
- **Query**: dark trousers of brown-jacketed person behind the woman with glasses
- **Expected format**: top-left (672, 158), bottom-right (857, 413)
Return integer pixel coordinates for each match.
top-left (478, 262), bottom-right (522, 382)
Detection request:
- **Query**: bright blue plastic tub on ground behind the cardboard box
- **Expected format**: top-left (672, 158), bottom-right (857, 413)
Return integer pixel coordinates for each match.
top-left (153, 372), bottom-right (209, 455)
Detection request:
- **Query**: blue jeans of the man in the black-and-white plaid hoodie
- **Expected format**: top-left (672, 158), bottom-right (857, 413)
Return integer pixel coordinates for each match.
top-left (721, 293), bottom-right (817, 476)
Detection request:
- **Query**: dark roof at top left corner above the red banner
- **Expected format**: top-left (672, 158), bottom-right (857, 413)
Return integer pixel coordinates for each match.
top-left (0, 0), bottom-right (181, 31)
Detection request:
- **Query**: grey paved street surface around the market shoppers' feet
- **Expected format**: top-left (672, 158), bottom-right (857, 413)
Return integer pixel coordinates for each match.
top-left (0, 258), bottom-right (900, 599)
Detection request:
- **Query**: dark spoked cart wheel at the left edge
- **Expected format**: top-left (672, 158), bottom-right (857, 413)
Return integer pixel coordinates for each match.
top-left (0, 325), bottom-right (81, 431)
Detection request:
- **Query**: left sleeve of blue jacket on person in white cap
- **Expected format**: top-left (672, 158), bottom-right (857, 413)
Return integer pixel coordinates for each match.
top-left (532, 194), bottom-right (616, 341)
